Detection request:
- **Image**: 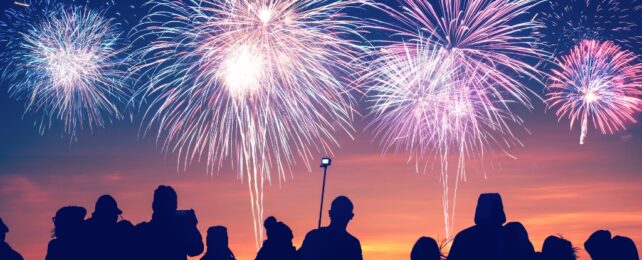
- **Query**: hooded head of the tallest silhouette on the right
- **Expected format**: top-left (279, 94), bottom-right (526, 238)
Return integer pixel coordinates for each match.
top-left (475, 193), bottom-right (506, 226)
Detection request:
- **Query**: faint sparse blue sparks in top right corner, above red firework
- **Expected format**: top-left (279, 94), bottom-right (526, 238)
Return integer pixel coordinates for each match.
top-left (537, 0), bottom-right (642, 54)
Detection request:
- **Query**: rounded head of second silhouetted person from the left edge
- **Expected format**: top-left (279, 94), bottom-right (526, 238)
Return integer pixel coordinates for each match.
top-left (52, 206), bottom-right (87, 238)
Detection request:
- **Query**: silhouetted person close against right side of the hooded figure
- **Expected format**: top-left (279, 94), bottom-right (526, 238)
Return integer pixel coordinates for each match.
top-left (504, 222), bottom-right (535, 260)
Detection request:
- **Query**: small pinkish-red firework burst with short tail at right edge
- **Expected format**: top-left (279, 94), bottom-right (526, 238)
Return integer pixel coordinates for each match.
top-left (546, 40), bottom-right (642, 144)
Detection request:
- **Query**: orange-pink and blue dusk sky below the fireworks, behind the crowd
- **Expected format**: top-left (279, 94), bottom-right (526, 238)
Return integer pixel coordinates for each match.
top-left (0, 0), bottom-right (642, 259)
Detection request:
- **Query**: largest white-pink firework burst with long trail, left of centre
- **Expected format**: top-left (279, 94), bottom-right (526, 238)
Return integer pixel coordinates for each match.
top-left (134, 0), bottom-right (363, 248)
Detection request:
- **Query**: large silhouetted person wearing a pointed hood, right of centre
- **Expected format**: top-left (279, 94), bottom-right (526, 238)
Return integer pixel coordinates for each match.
top-left (448, 193), bottom-right (506, 260)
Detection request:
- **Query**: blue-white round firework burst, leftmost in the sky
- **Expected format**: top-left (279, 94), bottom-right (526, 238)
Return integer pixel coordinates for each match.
top-left (0, 1), bottom-right (128, 140)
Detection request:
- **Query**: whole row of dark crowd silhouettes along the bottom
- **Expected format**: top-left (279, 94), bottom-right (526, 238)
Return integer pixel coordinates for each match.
top-left (0, 185), bottom-right (639, 260)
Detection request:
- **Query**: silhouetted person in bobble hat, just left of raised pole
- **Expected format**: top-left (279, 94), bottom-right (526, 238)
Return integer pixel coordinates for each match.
top-left (256, 216), bottom-right (297, 260)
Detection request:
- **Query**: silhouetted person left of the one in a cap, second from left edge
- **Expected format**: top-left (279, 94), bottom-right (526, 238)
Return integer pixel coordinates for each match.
top-left (45, 206), bottom-right (87, 260)
